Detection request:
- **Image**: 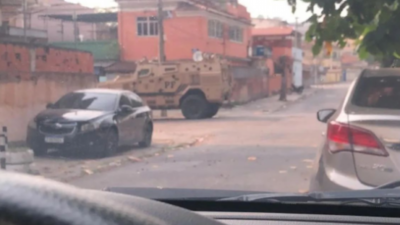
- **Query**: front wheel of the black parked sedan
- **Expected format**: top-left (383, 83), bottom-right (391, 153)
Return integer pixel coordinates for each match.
top-left (98, 129), bottom-right (118, 157)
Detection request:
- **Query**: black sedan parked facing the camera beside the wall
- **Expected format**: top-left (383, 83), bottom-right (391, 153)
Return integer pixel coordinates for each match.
top-left (27, 89), bottom-right (153, 157)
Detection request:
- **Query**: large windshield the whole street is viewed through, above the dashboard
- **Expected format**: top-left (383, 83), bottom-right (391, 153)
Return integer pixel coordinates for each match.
top-left (0, 0), bottom-right (400, 209)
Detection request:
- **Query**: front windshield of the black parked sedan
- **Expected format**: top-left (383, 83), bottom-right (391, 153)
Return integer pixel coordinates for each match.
top-left (52, 92), bottom-right (117, 111)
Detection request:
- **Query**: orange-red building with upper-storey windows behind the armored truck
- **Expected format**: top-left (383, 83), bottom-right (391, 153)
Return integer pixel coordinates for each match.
top-left (117, 0), bottom-right (251, 63)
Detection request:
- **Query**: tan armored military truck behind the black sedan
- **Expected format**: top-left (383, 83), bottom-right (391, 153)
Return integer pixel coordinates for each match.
top-left (99, 56), bottom-right (232, 119)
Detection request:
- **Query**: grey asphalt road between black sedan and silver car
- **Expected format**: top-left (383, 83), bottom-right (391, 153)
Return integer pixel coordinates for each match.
top-left (71, 84), bottom-right (347, 192)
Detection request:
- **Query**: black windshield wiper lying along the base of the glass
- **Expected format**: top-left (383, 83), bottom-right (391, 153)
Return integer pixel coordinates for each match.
top-left (218, 189), bottom-right (400, 206)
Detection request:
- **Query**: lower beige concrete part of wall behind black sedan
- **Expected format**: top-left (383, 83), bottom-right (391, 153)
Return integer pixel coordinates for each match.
top-left (0, 74), bottom-right (96, 141)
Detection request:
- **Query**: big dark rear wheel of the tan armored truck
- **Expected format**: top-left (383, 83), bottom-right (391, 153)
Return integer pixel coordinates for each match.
top-left (181, 95), bottom-right (208, 120)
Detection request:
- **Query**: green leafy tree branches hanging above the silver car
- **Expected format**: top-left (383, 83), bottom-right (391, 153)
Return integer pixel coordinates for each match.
top-left (287, 0), bottom-right (400, 67)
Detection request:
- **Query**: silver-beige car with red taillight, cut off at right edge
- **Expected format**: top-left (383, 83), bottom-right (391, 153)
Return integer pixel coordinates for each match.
top-left (310, 69), bottom-right (400, 191)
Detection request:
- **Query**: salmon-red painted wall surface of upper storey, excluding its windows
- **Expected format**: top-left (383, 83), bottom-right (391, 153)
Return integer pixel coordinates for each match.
top-left (118, 11), bottom-right (251, 61)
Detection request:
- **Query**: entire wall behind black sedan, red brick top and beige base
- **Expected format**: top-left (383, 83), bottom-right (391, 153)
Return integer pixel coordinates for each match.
top-left (0, 44), bottom-right (96, 141)
